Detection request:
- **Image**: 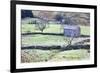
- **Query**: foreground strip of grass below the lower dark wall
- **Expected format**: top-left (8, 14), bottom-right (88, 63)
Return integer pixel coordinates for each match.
top-left (21, 49), bottom-right (89, 63)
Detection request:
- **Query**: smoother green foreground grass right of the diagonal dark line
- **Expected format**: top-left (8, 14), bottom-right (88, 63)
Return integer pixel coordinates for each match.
top-left (52, 49), bottom-right (89, 61)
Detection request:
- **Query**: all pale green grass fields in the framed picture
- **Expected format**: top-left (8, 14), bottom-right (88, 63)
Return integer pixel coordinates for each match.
top-left (21, 24), bottom-right (90, 63)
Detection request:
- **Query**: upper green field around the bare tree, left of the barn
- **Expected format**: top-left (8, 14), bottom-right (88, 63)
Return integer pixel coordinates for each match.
top-left (22, 24), bottom-right (63, 33)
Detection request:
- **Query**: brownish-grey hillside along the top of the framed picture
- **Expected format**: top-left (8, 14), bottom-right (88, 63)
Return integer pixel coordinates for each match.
top-left (22, 10), bottom-right (90, 26)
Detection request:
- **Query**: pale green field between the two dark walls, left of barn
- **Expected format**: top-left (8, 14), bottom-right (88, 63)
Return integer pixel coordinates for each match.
top-left (22, 34), bottom-right (66, 45)
